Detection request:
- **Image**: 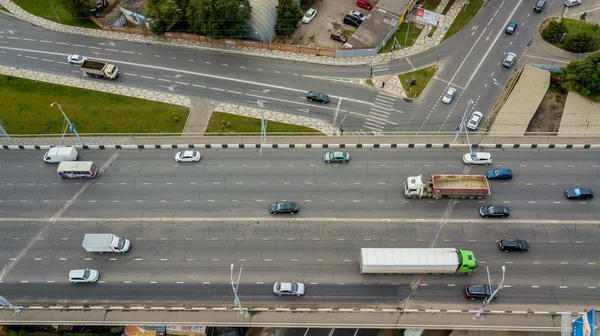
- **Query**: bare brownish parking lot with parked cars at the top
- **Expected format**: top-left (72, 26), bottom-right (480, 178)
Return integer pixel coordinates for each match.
top-left (281, 0), bottom-right (374, 49)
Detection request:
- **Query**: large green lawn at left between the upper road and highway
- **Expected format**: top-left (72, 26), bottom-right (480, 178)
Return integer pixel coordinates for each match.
top-left (0, 75), bottom-right (189, 134)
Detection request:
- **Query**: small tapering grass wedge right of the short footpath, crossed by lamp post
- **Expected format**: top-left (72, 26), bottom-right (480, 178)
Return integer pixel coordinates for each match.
top-left (204, 111), bottom-right (323, 135)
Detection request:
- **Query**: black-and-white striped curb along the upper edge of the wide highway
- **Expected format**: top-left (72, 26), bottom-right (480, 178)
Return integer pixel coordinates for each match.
top-left (1, 144), bottom-right (600, 150)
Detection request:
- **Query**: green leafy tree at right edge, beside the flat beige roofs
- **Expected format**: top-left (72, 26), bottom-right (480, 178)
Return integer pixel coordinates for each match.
top-left (561, 53), bottom-right (600, 97)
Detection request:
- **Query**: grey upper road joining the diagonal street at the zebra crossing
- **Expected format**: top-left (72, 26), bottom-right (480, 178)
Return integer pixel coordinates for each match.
top-left (0, 0), bottom-right (561, 132)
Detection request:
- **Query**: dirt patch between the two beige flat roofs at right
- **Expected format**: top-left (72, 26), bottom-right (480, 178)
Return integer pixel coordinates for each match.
top-left (527, 83), bottom-right (567, 135)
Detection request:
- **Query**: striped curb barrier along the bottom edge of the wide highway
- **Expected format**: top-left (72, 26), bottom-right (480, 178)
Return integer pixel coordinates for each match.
top-left (5, 305), bottom-right (585, 315)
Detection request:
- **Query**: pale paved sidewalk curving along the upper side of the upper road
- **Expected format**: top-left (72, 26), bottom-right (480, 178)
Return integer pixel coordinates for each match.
top-left (0, 0), bottom-right (466, 66)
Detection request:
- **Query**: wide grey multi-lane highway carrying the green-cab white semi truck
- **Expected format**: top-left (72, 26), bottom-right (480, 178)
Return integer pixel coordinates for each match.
top-left (0, 150), bottom-right (600, 311)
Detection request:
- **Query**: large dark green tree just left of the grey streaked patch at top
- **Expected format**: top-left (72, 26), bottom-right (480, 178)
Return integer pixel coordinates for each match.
top-left (186, 0), bottom-right (252, 39)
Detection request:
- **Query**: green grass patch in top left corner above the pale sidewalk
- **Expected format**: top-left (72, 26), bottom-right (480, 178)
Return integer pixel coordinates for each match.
top-left (12, 0), bottom-right (100, 29)
